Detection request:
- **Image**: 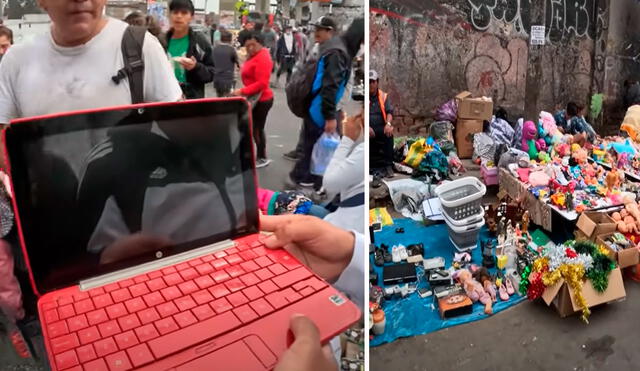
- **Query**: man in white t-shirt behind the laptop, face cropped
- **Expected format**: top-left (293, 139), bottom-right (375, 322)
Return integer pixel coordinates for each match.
top-left (0, 0), bottom-right (182, 124)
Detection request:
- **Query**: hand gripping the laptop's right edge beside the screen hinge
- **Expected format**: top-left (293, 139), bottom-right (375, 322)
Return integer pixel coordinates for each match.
top-left (260, 215), bottom-right (355, 282)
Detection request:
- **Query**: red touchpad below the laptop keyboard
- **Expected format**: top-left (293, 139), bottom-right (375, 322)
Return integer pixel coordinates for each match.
top-left (175, 335), bottom-right (278, 371)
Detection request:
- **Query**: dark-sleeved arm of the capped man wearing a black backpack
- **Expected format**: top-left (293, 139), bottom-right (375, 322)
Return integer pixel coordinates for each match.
top-left (319, 52), bottom-right (349, 121)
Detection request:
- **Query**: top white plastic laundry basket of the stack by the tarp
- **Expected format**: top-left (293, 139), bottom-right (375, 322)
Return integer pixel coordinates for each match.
top-left (435, 177), bottom-right (487, 220)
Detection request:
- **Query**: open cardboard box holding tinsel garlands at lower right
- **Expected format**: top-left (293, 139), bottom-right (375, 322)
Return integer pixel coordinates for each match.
top-left (542, 267), bottom-right (627, 318)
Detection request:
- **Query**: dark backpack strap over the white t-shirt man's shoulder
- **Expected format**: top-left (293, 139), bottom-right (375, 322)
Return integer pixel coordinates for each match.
top-left (111, 26), bottom-right (147, 104)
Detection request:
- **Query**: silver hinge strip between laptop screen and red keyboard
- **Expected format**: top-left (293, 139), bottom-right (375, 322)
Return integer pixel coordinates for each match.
top-left (79, 240), bottom-right (235, 291)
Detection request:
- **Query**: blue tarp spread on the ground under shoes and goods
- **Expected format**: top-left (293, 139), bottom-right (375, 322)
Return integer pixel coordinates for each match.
top-left (370, 219), bottom-right (526, 347)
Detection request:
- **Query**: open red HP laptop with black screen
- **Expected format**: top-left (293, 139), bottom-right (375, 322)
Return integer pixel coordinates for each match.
top-left (4, 98), bottom-right (361, 371)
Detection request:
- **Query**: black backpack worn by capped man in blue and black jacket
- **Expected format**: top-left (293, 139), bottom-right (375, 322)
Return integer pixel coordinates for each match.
top-left (285, 39), bottom-right (349, 118)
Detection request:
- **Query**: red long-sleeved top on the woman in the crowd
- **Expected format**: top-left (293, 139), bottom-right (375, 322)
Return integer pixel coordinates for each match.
top-left (240, 48), bottom-right (273, 102)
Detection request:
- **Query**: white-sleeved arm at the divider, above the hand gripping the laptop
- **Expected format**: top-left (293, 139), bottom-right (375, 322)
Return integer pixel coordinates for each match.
top-left (322, 139), bottom-right (364, 195)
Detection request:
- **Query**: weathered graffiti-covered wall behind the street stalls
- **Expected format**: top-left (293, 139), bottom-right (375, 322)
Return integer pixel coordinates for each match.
top-left (370, 0), bottom-right (607, 131)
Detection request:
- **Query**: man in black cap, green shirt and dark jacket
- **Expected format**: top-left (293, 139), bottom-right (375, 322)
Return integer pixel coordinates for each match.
top-left (164, 0), bottom-right (214, 99)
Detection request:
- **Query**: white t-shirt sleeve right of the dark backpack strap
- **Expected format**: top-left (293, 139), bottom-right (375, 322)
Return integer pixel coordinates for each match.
top-left (142, 32), bottom-right (182, 102)
